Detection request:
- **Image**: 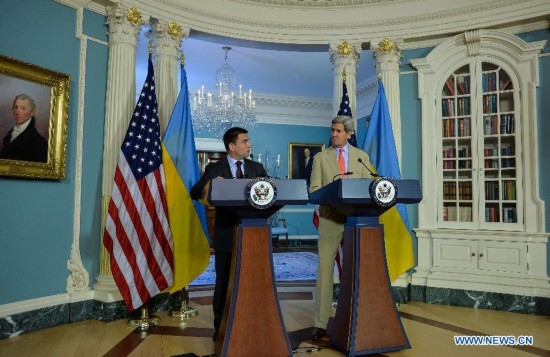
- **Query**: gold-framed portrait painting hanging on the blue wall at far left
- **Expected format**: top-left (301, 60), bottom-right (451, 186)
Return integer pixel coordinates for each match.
top-left (0, 55), bottom-right (71, 180)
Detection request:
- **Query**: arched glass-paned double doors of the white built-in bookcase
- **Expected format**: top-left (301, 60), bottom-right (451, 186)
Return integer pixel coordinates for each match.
top-left (438, 61), bottom-right (520, 229)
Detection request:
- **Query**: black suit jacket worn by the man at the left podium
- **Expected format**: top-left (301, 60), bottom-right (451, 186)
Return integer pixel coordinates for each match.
top-left (191, 159), bottom-right (267, 252)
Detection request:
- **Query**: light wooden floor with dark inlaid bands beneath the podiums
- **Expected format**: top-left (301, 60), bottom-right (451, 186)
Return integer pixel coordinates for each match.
top-left (0, 284), bottom-right (550, 357)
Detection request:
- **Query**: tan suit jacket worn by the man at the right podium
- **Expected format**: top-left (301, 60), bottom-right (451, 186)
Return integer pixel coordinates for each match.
top-left (309, 145), bottom-right (372, 237)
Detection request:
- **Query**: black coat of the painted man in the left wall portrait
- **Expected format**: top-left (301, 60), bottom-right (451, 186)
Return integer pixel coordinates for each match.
top-left (0, 117), bottom-right (48, 162)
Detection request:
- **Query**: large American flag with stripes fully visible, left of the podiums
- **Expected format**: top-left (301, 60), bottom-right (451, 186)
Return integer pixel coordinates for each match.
top-left (103, 56), bottom-right (174, 311)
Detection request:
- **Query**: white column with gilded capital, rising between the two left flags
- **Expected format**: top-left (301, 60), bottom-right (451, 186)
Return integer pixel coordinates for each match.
top-left (153, 21), bottom-right (190, 133)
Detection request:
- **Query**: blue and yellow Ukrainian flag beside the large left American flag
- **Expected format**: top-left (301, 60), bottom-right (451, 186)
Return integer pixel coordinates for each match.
top-left (162, 66), bottom-right (210, 293)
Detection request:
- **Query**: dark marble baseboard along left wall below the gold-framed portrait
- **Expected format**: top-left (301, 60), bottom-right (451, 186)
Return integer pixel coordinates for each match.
top-left (0, 292), bottom-right (181, 339)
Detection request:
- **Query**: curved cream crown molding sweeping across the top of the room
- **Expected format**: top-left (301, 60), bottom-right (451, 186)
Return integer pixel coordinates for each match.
top-left (89, 0), bottom-right (550, 44)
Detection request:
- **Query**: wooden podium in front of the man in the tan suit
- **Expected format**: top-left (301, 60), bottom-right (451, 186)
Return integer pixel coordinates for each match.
top-left (310, 179), bottom-right (422, 356)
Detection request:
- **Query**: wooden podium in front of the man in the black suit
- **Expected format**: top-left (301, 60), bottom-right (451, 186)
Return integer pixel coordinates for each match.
top-left (208, 179), bottom-right (308, 357)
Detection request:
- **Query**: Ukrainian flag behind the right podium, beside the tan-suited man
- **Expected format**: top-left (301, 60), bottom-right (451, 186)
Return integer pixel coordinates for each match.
top-left (363, 81), bottom-right (414, 282)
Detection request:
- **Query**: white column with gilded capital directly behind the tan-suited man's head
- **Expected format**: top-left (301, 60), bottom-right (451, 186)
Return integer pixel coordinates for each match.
top-left (329, 41), bottom-right (361, 121)
